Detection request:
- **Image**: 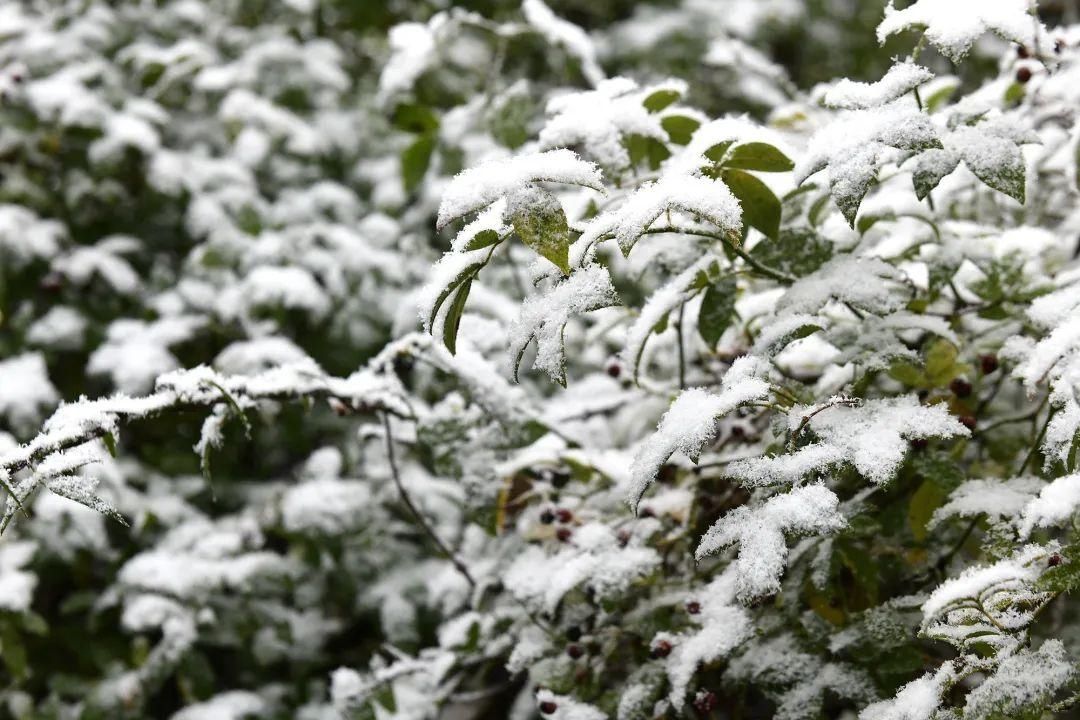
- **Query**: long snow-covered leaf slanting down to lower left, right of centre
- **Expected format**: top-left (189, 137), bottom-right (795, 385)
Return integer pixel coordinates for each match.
top-left (627, 356), bottom-right (770, 512)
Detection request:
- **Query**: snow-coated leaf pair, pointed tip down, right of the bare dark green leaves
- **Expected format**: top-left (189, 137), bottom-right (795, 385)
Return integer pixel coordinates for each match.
top-left (795, 99), bottom-right (941, 228)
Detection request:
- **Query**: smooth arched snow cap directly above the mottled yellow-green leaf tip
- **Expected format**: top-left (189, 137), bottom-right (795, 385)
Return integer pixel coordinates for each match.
top-left (436, 150), bottom-right (604, 228)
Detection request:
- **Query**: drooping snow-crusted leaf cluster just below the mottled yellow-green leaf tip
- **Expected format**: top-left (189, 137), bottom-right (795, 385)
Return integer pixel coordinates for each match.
top-left (509, 264), bottom-right (617, 385)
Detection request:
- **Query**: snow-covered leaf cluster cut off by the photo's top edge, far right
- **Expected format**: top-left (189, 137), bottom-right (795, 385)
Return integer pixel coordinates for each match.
top-left (877, 0), bottom-right (1047, 62)
